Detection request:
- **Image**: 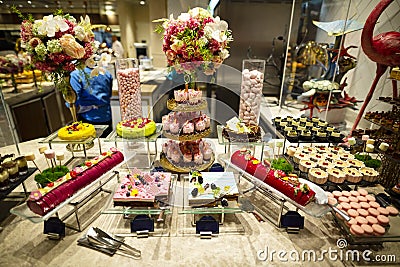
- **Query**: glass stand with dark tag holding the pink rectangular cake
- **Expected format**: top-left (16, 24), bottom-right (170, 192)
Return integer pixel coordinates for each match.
top-left (99, 174), bottom-right (178, 238)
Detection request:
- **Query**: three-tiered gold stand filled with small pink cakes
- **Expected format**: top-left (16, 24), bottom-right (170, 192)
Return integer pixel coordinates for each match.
top-left (161, 88), bottom-right (214, 172)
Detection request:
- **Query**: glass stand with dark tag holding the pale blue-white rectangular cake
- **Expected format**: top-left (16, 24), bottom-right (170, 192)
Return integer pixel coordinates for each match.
top-left (174, 175), bottom-right (245, 238)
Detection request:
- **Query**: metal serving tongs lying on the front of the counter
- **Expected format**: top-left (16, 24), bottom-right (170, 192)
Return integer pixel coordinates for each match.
top-left (86, 227), bottom-right (142, 259)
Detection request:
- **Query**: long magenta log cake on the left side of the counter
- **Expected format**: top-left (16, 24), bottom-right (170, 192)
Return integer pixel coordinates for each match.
top-left (27, 148), bottom-right (124, 216)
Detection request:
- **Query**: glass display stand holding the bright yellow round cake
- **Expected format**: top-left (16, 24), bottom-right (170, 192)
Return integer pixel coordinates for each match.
top-left (39, 125), bottom-right (108, 162)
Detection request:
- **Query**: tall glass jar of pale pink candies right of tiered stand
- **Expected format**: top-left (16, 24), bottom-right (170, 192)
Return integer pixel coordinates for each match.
top-left (239, 59), bottom-right (265, 124)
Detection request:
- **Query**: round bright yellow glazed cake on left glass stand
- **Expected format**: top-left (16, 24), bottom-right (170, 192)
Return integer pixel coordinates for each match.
top-left (58, 122), bottom-right (96, 141)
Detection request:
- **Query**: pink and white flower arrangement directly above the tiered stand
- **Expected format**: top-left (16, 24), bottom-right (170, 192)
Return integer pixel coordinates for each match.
top-left (155, 7), bottom-right (233, 81)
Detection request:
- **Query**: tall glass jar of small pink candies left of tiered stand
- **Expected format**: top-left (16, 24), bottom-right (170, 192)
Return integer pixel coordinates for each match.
top-left (115, 58), bottom-right (142, 120)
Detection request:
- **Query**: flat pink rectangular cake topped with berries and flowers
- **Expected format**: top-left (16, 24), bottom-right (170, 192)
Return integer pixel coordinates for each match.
top-left (113, 168), bottom-right (171, 206)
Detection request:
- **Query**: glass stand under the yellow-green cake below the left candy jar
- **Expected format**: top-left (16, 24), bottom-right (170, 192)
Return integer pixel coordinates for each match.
top-left (104, 123), bottom-right (162, 169)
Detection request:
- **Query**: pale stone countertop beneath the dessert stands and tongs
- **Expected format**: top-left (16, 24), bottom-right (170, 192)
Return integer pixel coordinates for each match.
top-left (0, 139), bottom-right (400, 266)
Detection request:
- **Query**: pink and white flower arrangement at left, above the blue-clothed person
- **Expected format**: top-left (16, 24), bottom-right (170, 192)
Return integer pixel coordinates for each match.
top-left (13, 8), bottom-right (101, 93)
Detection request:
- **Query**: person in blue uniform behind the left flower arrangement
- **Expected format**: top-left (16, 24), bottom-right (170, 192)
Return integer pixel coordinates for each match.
top-left (70, 67), bottom-right (113, 137)
